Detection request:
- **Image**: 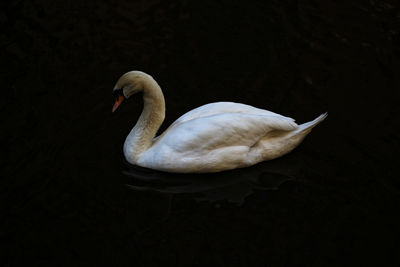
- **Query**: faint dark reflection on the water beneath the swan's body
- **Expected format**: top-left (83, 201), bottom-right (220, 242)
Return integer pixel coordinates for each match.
top-left (122, 162), bottom-right (294, 204)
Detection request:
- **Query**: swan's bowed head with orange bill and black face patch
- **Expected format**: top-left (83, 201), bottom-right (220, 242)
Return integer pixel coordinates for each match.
top-left (112, 70), bottom-right (149, 112)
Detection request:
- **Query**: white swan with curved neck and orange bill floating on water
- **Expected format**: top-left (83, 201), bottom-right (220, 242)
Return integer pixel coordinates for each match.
top-left (112, 71), bottom-right (327, 173)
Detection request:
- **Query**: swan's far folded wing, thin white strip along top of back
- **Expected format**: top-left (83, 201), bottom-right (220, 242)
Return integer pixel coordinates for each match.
top-left (171, 102), bottom-right (294, 126)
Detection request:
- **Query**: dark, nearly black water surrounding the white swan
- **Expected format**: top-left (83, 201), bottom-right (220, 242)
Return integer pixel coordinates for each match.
top-left (0, 0), bottom-right (400, 266)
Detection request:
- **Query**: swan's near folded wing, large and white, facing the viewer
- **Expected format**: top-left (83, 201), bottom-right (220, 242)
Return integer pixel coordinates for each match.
top-left (155, 113), bottom-right (298, 154)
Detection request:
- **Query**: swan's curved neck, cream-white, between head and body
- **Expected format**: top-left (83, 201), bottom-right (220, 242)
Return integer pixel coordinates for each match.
top-left (124, 76), bottom-right (165, 164)
